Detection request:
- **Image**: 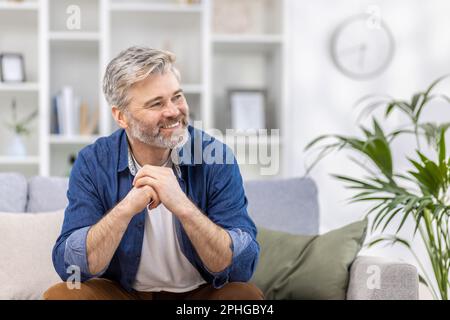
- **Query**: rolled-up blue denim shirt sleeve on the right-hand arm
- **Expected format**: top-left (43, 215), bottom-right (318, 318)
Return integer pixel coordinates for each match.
top-left (205, 148), bottom-right (260, 288)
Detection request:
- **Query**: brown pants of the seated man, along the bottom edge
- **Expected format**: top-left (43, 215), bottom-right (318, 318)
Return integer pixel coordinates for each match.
top-left (43, 278), bottom-right (264, 300)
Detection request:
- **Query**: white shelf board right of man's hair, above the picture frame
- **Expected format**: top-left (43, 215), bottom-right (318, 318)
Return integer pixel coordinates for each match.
top-left (212, 34), bottom-right (283, 52)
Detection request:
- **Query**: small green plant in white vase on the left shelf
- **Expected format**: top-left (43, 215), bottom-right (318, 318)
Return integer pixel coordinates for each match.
top-left (6, 99), bottom-right (38, 156)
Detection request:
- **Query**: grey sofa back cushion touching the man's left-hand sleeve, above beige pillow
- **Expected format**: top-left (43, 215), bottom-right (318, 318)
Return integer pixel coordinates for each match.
top-left (27, 176), bottom-right (69, 212)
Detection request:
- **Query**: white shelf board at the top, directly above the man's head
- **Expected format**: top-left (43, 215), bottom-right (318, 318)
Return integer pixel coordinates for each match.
top-left (111, 3), bottom-right (203, 13)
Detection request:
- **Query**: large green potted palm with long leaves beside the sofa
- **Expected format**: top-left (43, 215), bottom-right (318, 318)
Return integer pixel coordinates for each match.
top-left (305, 76), bottom-right (450, 300)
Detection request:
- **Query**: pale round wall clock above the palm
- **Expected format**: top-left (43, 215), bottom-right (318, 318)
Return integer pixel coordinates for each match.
top-left (331, 14), bottom-right (394, 79)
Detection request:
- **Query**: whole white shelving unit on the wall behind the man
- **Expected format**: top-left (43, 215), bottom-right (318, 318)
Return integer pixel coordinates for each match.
top-left (0, 0), bottom-right (289, 179)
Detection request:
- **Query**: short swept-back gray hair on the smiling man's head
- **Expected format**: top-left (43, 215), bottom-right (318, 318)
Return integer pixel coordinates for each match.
top-left (103, 46), bottom-right (180, 111)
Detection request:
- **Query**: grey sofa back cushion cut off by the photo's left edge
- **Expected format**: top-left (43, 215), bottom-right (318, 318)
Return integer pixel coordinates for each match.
top-left (0, 172), bottom-right (27, 212)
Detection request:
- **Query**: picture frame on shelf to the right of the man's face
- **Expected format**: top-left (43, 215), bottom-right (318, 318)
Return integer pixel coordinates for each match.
top-left (228, 89), bottom-right (267, 130)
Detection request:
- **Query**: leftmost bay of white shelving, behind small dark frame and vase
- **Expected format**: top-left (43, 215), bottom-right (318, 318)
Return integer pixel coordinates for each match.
top-left (0, 1), bottom-right (42, 175)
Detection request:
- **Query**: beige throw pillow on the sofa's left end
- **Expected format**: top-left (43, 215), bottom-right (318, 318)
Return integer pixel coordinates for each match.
top-left (0, 210), bottom-right (64, 300)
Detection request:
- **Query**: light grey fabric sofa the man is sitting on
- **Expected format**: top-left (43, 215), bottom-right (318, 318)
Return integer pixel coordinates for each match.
top-left (0, 173), bottom-right (418, 300)
